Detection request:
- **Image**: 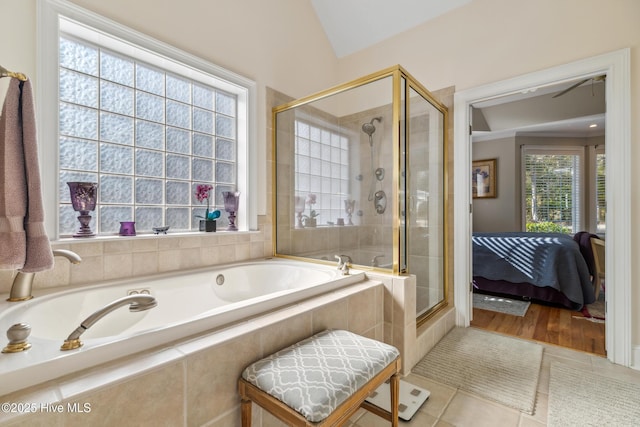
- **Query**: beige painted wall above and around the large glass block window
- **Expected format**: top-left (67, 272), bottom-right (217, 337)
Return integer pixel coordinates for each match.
top-left (0, 0), bottom-right (337, 219)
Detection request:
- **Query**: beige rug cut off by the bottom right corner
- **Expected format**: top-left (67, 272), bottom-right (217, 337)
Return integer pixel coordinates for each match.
top-left (547, 362), bottom-right (640, 427)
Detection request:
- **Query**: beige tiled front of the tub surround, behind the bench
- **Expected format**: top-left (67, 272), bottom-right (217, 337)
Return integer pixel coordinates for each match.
top-left (0, 280), bottom-right (385, 426)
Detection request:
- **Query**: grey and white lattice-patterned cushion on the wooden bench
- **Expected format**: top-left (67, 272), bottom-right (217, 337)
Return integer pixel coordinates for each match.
top-left (242, 330), bottom-right (400, 422)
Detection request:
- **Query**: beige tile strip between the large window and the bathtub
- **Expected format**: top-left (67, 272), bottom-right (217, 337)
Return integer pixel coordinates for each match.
top-left (0, 219), bottom-right (273, 293)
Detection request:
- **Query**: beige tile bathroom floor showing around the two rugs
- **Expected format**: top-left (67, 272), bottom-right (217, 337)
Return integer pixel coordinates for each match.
top-left (349, 344), bottom-right (640, 427)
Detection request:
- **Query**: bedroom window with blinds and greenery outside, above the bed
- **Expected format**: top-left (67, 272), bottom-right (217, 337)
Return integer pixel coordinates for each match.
top-left (522, 147), bottom-right (584, 234)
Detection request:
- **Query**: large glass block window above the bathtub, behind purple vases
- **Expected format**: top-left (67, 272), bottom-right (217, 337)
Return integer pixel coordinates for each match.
top-left (58, 33), bottom-right (238, 236)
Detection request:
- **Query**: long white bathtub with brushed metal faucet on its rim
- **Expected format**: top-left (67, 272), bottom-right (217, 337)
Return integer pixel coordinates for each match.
top-left (0, 259), bottom-right (365, 395)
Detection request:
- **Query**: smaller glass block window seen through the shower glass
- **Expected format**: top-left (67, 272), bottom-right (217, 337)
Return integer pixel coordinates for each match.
top-left (295, 120), bottom-right (349, 225)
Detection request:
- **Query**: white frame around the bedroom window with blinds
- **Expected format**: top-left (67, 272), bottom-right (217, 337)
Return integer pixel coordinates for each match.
top-left (520, 145), bottom-right (588, 233)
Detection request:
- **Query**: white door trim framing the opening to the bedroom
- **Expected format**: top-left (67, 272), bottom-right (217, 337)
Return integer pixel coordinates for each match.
top-left (454, 49), bottom-right (632, 366)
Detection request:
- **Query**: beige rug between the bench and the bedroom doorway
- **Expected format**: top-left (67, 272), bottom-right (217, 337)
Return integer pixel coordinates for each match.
top-left (413, 328), bottom-right (543, 414)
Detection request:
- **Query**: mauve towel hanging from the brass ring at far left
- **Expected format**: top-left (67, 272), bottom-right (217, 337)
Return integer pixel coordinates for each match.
top-left (0, 79), bottom-right (53, 273)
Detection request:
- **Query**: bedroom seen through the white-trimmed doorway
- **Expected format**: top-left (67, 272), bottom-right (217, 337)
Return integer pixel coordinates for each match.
top-left (472, 76), bottom-right (606, 354)
